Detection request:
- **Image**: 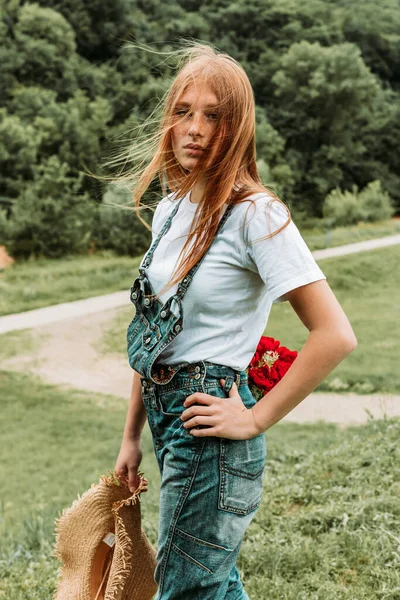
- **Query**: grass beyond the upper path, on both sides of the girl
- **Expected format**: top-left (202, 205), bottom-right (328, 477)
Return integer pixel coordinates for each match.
top-left (0, 219), bottom-right (400, 315)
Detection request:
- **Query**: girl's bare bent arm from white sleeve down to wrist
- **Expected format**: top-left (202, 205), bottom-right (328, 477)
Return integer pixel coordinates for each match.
top-left (251, 280), bottom-right (357, 433)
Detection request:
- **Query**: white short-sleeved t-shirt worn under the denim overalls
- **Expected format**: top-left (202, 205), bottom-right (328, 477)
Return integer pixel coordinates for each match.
top-left (142, 193), bottom-right (326, 371)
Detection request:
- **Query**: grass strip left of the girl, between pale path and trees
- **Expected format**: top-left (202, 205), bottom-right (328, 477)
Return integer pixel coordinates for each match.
top-left (0, 248), bottom-right (141, 315)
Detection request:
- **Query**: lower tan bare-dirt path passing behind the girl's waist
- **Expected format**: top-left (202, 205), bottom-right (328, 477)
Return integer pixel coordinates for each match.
top-left (2, 309), bottom-right (400, 427)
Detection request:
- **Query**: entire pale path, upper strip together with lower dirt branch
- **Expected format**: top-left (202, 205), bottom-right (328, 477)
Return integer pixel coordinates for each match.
top-left (0, 235), bottom-right (400, 427)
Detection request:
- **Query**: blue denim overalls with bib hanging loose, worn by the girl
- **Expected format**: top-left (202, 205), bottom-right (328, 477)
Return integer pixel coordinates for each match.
top-left (127, 199), bottom-right (267, 600)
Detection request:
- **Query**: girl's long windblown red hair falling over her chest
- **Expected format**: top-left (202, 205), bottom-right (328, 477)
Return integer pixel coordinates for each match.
top-left (104, 40), bottom-right (291, 298)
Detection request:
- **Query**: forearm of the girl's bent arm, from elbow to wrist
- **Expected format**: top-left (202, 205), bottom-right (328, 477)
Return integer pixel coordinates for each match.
top-left (252, 330), bottom-right (356, 432)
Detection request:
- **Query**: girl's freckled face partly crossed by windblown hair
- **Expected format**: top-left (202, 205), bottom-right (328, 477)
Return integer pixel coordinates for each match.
top-left (172, 84), bottom-right (218, 171)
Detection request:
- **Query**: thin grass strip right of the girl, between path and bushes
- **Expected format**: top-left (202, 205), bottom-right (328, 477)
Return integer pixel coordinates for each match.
top-left (299, 219), bottom-right (400, 250)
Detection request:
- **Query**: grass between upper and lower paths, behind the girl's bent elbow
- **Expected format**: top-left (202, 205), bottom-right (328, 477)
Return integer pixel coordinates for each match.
top-left (102, 246), bottom-right (400, 394)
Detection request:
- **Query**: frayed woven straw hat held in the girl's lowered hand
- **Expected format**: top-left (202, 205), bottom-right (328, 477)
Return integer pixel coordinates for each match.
top-left (53, 471), bottom-right (157, 600)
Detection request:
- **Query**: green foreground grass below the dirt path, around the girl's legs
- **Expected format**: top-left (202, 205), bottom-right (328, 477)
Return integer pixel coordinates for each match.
top-left (0, 372), bottom-right (400, 600)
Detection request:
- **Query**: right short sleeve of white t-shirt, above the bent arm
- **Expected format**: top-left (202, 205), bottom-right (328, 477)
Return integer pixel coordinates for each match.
top-left (243, 194), bottom-right (326, 304)
